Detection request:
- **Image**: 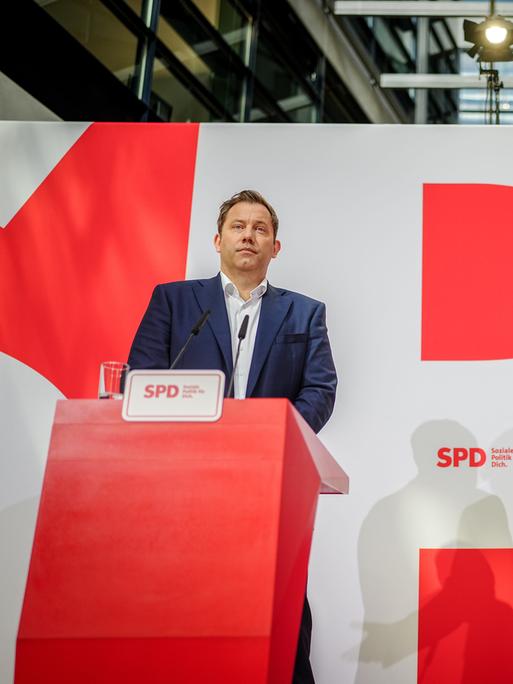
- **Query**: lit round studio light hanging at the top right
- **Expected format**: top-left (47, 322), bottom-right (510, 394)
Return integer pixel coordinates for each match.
top-left (463, 16), bottom-right (513, 62)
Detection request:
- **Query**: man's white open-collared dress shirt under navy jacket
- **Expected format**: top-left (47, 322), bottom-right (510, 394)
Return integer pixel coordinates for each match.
top-left (221, 271), bottom-right (267, 399)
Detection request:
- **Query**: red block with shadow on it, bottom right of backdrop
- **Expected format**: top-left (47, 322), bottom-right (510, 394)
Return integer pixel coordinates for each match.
top-left (418, 549), bottom-right (513, 684)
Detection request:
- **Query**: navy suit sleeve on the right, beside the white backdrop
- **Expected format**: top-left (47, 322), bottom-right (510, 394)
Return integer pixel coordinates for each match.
top-left (294, 303), bottom-right (337, 432)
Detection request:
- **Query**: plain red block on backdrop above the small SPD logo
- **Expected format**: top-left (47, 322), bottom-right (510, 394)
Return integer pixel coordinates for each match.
top-left (422, 184), bottom-right (513, 361)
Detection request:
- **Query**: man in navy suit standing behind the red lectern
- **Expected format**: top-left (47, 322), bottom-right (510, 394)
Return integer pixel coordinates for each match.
top-left (128, 190), bottom-right (337, 684)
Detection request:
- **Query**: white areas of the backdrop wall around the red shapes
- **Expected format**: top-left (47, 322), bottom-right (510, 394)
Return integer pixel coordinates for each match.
top-left (0, 124), bottom-right (513, 684)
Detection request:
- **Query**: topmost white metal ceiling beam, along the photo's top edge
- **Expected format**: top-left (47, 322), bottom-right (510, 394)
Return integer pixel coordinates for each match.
top-left (333, 0), bottom-right (513, 17)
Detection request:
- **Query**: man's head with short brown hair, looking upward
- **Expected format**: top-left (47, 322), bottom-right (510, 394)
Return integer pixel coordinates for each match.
top-left (214, 202), bottom-right (281, 278)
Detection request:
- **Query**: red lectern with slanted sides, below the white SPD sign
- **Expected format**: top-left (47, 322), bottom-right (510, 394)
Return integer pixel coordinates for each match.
top-left (15, 399), bottom-right (348, 684)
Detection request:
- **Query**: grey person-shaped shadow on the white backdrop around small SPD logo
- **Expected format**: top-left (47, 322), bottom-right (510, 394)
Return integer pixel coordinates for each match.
top-left (350, 420), bottom-right (512, 684)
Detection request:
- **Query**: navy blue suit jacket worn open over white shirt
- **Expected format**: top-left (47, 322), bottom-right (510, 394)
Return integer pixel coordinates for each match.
top-left (128, 275), bottom-right (337, 432)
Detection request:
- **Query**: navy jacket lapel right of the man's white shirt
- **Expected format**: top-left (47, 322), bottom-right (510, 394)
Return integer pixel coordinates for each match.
top-left (246, 285), bottom-right (290, 397)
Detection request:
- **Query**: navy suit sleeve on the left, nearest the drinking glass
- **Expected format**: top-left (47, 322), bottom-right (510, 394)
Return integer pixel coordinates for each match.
top-left (128, 285), bottom-right (171, 370)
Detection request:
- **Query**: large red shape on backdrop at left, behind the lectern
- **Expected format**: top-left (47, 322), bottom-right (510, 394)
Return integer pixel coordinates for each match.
top-left (0, 124), bottom-right (199, 397)
